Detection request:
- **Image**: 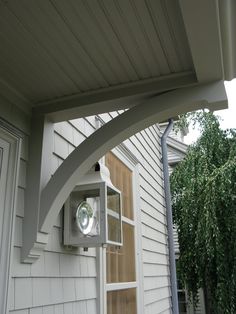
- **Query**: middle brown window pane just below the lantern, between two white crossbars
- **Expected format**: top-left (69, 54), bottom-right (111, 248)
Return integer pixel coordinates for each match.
top-left (107, 223), bottom-right (136, 283)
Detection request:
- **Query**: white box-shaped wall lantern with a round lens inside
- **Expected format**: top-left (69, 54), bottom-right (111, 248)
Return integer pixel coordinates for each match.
top-left (64, 163), bottom-right (122, 247)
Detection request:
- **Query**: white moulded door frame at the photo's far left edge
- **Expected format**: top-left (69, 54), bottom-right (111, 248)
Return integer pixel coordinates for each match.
top-left (0, 120), bottom-right (22, 314)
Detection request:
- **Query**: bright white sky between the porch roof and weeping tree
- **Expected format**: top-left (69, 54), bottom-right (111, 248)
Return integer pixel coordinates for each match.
top-left (184, 79), bottom-right (236, 144)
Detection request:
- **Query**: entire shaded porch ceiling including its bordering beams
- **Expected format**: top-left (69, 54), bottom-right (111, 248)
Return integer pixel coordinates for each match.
top-left (0, 0), bottom-right (234, 121)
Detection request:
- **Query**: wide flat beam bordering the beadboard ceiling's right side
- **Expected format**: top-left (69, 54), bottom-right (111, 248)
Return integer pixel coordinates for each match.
top-left (179, 0), bottom-right (224, 83)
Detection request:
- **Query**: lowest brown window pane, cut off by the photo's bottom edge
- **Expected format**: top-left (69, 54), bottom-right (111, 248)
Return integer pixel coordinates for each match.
top-left (107, 288), bottom-right (137, 314)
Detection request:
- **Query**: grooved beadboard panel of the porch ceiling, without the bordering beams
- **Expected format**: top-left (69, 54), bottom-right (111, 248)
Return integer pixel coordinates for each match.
top-left (0, 0), bottom-right (193, 106)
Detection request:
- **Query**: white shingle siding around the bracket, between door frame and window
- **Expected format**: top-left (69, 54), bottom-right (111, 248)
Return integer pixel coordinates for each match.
top-left (9, 119), bottom-right (97, 314)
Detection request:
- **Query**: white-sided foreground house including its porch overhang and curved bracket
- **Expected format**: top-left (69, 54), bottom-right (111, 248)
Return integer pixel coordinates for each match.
top-left (0, 0), bottom-right (236, 314)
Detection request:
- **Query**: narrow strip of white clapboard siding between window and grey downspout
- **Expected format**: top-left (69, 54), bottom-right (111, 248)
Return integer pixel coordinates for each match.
top-left (118, 121), bottom-right (171, 313)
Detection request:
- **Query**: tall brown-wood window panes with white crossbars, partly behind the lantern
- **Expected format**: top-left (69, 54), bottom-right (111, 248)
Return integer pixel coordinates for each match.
top-left (106, 153), bottom-right (137, 314)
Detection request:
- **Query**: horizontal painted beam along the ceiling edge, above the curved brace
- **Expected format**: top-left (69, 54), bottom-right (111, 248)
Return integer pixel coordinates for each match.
top-left (33, 71), bottom-right (196, 122)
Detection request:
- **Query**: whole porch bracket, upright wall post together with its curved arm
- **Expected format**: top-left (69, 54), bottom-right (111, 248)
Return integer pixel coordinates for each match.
top-left (22, 81), bottom-right (227, 262)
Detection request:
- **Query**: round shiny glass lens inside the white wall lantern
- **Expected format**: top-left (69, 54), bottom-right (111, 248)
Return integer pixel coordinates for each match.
top-left (76, 201), bottom-right (94, 234)
